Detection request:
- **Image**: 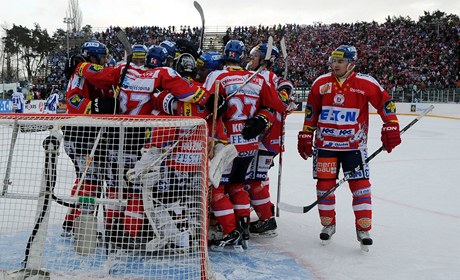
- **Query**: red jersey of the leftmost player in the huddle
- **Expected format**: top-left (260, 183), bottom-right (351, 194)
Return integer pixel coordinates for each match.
top-left (66, 62), bottom-right (120, 114)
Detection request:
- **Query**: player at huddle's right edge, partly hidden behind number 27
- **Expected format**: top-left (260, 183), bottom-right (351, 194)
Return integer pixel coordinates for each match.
top-left (242, 43), bottom-right (293, 236)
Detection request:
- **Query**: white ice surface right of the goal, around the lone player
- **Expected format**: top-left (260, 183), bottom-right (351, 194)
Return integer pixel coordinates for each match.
top-left (234, 108), bottom-right (460, 280)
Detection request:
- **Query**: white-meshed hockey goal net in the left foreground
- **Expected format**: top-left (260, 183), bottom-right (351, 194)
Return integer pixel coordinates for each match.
top-left (0, 114), bottom-right (212, 279)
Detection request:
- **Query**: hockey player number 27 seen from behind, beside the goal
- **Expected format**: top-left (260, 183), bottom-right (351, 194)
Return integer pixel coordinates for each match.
top-left (204, 40), bottom-right (287, 250)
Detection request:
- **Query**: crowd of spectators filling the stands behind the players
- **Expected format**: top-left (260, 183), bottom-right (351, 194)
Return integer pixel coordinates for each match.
top-left (47, 20), bottom-right (460, 100)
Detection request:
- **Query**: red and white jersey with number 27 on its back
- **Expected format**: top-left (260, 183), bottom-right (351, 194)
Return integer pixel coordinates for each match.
top-left (204, 67), bottom-right (287, 153)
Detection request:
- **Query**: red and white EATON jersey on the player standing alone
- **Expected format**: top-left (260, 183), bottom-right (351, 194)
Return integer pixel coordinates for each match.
top-left (303, 72), bottom-right (398, 150)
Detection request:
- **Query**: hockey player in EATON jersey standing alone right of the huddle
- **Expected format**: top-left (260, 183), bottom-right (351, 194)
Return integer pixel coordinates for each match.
top-left (297, 45), bottom-right (401, 249)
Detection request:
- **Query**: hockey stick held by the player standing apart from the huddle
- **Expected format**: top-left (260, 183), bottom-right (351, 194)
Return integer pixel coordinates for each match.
top-left (279, 105), bottom-right (434, 214)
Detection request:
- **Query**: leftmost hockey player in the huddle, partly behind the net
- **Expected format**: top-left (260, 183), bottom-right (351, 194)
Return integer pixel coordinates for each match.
top-left (63, 40), bottom-right (125, 236)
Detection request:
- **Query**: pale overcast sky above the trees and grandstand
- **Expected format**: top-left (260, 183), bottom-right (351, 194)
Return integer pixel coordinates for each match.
top-left (0, 0), bottom-right (460, 34)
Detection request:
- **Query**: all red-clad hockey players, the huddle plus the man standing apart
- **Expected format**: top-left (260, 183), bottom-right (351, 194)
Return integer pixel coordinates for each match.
top-left (63, 30), bottom-right (401, 254)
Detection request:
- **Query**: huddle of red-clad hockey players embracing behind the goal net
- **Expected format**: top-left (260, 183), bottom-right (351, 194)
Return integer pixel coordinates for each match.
top-left (59, 34), bottom-right (295, 251)
